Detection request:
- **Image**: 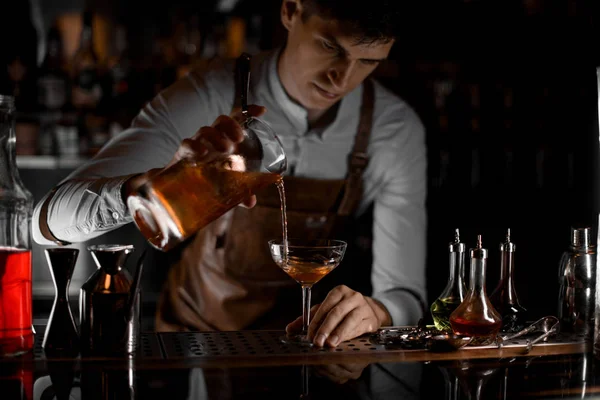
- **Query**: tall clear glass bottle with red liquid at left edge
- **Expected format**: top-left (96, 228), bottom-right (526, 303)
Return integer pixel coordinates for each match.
top-left (0, 95), bottom-right (33, 357)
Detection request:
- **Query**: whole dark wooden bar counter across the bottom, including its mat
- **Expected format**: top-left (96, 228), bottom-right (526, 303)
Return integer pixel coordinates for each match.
top-left (0, 326), bottom-right (600, 400)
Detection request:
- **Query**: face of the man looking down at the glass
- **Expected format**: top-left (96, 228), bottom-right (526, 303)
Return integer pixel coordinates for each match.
top-left (279, 1), bottom-right (393, 110)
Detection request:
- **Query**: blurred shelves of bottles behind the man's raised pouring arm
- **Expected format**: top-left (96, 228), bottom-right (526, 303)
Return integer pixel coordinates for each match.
top-left (0, 5), bottom-right (261, 161)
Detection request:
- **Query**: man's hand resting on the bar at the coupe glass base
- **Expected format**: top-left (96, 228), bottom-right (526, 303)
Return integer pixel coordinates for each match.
top-left (286, 285), bottom-right (391, 347)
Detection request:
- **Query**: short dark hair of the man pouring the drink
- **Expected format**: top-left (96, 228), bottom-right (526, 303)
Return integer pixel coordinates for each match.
top-left (302, 0), bottom-right (402, 44)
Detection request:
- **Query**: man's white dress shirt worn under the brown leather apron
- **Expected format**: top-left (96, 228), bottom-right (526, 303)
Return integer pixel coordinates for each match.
top-left (33, 50), bottom-right (427, 325)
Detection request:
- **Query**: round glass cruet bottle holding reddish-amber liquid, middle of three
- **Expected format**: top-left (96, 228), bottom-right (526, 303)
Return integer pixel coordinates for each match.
top-left (450, 235), bottom-right (502, 344)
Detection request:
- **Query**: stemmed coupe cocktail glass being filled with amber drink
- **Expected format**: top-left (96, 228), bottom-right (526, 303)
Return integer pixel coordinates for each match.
top-left (269, 239), bottom-right (346, 346)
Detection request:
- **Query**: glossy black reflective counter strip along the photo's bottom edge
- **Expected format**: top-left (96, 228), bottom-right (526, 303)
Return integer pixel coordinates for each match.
top-left (0, 354), bottom-right (599, 400)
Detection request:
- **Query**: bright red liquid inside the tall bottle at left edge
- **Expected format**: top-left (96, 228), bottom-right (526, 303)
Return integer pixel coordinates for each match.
top-left (0, 247), bottom-right (33, 355)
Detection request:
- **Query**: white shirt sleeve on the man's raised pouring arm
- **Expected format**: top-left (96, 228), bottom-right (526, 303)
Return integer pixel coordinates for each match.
top-left (32, 61), bottom-right (233, 245)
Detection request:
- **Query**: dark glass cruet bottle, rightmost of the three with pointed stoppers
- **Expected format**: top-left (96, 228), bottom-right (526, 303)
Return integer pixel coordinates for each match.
top-left (490, 228), bottom-right (527, 333)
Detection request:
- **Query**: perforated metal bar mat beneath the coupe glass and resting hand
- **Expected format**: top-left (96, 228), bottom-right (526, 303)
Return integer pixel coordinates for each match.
top-left (159, 331), bottom-right (386, 359)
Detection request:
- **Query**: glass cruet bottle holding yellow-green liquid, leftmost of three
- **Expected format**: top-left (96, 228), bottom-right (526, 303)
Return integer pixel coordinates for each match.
top-left (431, 229), bottom-right (467, 331)
